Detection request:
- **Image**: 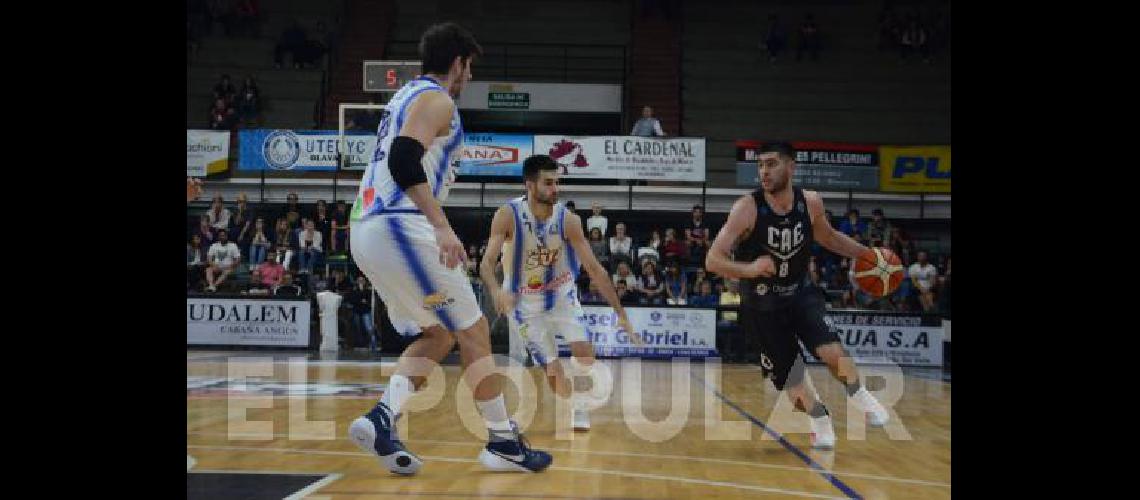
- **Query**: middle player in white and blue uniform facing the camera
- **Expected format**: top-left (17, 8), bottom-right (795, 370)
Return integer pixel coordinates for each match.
top-left (479, 155), bottom-right (641, 431)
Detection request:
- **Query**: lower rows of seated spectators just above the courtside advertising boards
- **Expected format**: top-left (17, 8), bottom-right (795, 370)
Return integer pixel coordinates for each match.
top-left (186, 194), bottom-right (950, 321)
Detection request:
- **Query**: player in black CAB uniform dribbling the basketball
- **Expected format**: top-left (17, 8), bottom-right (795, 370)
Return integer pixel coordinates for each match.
top-left (706, 142), bottom-right (890, 449)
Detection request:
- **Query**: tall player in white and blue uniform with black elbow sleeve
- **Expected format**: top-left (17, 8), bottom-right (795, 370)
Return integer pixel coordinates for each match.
top-left (349, 23), bottom-right (552, 474)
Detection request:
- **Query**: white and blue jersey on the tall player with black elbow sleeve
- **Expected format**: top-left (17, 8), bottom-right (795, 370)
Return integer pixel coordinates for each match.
top-left (350, 76), bottom-right (463, 221)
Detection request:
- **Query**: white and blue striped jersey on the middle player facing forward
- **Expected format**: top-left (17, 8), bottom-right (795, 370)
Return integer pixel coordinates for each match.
top-left (503, 196), bottom-right (580, 312)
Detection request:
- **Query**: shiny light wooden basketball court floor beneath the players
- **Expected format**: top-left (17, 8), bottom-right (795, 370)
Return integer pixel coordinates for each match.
top-left (186, 351), bottom-right (951, 499)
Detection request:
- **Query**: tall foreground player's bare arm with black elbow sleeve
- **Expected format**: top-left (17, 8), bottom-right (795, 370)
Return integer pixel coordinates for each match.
top-left (388, 92), bottom-right (467, 268)
